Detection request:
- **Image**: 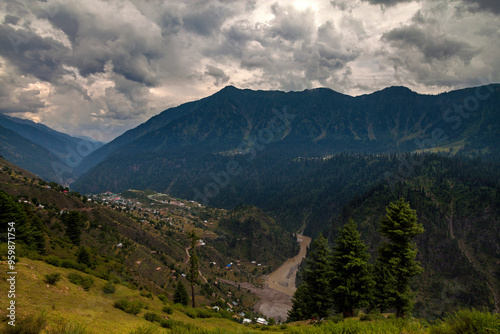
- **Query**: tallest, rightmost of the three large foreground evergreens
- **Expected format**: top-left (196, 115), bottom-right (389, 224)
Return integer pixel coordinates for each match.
top-left (377, 198), bottom-right (424, 317)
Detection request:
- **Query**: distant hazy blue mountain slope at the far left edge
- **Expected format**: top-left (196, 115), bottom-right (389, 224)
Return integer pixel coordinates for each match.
top-left (0, 114), bottom-right (103, 184)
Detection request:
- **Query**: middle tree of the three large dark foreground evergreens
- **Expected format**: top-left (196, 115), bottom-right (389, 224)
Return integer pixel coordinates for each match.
top-left (331, 219), bottom-right (373, 317)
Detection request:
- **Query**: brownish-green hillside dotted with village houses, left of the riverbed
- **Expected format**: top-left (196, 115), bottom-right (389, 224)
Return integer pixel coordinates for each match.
top-left (0, 160), bottom-right (296, 324)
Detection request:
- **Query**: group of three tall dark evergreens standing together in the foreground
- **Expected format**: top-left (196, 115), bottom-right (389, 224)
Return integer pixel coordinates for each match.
top-left (288, 197), bottom-right (424, 321)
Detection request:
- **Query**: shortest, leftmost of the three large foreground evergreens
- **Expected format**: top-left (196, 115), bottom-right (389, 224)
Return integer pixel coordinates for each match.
top-left (289, 234), bottom-right (332, 321)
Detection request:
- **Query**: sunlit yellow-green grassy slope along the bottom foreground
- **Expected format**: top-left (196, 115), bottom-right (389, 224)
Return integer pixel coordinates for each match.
top-left (0, 258), bottom-right (500, 334)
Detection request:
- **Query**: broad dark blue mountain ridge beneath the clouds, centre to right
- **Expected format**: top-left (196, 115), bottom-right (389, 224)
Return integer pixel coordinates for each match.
top-left (73, 84), bottom-right (500, 198)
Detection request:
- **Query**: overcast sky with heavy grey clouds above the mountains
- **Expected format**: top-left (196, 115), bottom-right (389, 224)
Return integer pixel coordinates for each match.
top-left (0, 0), bottom-right (500, 141)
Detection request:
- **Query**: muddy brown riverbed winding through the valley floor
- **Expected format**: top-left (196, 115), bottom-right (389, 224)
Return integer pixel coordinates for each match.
top-left (267, 234), bottom-right (311, 296)
